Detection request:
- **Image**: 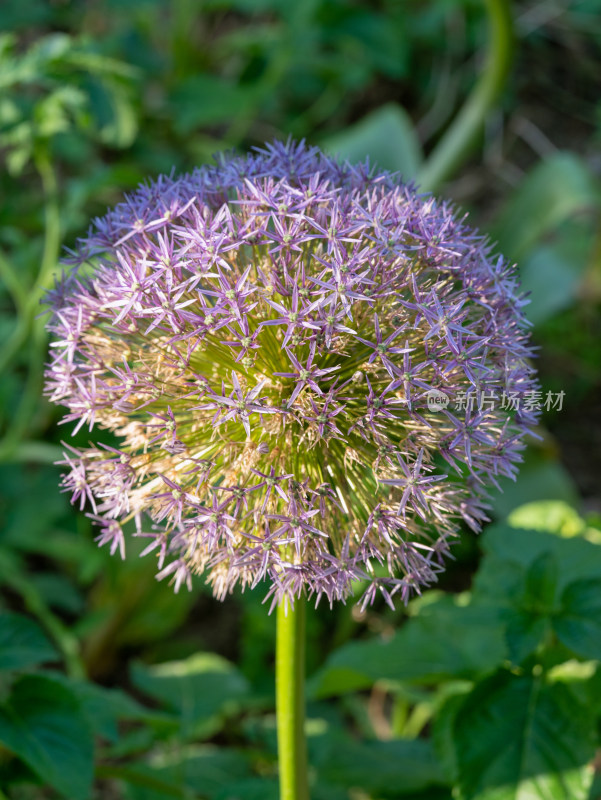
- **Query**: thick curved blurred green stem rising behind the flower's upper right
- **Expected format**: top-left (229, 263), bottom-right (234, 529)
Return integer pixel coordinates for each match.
top-left (416, 0), bottom-right (514, 192)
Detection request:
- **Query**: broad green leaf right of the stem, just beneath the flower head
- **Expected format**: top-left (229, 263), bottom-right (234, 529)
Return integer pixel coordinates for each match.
top-left (309, 597), bottom-right (506, 697)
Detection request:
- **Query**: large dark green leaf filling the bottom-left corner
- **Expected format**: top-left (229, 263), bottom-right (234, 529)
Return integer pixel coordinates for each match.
top-left (0, 675), bottom-right (94, 800)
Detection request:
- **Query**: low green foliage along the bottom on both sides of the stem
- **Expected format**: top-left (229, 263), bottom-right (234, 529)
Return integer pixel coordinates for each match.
top-left (0, 501), bottom-right (601, 800)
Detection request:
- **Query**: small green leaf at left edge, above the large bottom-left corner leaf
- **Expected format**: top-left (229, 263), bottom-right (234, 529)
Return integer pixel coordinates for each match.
top-left (0, 612), bottom-right (59, 670)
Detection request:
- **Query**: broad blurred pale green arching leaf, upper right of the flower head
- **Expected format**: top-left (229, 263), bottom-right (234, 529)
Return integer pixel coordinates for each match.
top-left (491, 153), bottom-right (601, 262)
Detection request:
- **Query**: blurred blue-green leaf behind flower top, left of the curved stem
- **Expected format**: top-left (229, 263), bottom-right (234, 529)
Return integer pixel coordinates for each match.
top-left (322, 103), bottom-right (422, 180)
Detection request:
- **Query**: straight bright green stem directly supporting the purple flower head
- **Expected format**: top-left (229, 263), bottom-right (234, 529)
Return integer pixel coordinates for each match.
top-left (275, 598), bottom-right (309, 800)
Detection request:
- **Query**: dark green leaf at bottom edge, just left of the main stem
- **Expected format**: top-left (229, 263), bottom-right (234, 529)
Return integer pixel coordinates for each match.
top-left (124, 745), bottom-right (252, 800)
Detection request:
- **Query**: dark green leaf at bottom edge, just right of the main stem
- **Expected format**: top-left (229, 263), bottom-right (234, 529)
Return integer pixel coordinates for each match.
top-left (312, 734), bottom-right (445, 798)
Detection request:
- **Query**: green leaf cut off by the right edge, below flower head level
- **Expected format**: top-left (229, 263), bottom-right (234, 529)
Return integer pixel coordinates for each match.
top-left (553, 578), bottom-right (601, 659)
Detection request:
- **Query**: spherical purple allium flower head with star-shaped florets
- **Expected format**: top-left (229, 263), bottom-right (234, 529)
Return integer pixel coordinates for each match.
top-left (46, 142), bottom-right (537, 604)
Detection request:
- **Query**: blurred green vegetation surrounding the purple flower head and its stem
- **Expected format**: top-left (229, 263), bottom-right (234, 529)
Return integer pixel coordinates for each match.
top-left (0, 0), bottom-right (601, 800)
